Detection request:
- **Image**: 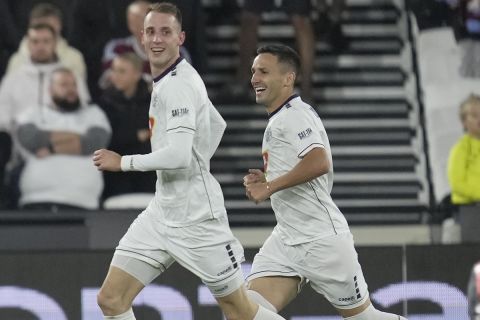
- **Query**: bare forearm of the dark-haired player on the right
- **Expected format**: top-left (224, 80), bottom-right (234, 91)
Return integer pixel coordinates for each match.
top-left (268, 148), bottom-right (330, 193)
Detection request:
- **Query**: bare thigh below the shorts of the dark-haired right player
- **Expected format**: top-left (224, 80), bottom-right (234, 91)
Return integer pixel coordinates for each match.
top-left (247, 276), bottom-right (301, 311)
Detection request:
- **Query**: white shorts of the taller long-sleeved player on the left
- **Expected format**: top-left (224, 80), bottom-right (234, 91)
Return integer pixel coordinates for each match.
top-left (112, 210), bottom-right (245, 297)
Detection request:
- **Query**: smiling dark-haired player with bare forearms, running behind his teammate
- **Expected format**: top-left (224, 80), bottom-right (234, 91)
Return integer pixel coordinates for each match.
top-left (244, 45), bottom-right (404, 320)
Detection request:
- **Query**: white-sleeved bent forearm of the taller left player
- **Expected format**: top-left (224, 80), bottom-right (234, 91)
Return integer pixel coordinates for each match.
top-left (121, 132), bottom-right (193, 171)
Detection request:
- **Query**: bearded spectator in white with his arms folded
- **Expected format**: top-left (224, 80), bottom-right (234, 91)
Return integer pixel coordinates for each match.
top-left (15, 68), bottom-right (110, 211)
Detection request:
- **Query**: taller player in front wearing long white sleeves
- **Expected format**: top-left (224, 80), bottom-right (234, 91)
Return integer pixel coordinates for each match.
top-left (93, 2), bottom-right (283, 320)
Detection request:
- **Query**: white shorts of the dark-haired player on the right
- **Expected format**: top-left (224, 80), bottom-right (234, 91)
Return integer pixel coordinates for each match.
top-left (247, 230), bottom-right (369, 309)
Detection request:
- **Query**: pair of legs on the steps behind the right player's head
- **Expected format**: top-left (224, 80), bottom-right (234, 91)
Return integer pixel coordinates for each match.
top-left (218, 0), bottom-right (315, 102)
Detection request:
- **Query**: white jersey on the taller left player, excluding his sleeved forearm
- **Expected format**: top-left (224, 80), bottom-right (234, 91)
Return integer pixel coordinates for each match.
top-left (147, 58), bottom-right (226, 227)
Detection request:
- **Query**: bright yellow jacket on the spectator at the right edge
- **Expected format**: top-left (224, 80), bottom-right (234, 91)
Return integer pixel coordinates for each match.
top-left (448, 134), bottom-right (480, 204)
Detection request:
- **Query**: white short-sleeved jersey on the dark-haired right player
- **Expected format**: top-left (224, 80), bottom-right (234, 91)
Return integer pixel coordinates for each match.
top-left (262, 95), bottom-right (349, 245)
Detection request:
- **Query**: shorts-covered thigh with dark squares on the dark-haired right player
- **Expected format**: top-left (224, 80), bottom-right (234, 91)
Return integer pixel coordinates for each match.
top-left (302, 233), bottom-right (368, 309)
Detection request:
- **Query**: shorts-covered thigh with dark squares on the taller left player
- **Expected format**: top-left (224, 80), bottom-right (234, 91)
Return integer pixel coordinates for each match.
top-left (168, 218), bottom-right (245, 297)
